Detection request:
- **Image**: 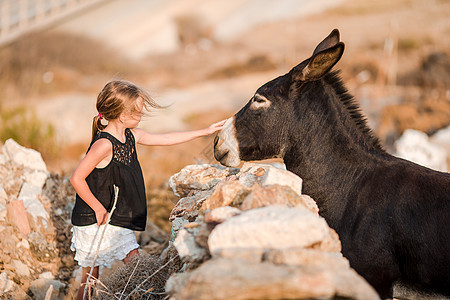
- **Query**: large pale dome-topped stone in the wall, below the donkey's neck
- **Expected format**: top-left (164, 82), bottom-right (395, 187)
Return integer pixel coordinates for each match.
top-left (208, 205), bottom-right (330, 256)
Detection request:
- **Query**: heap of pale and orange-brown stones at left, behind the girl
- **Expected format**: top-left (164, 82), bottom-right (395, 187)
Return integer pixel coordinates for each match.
top-left (0, 139), bottom-right (74, 299)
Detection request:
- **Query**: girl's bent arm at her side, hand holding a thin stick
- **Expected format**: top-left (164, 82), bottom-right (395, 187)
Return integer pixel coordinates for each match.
top-left (70, 139), bottom-right (112, 225)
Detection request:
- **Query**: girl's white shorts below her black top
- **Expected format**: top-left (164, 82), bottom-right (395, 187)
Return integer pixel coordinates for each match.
top-left (70, 224), bottom-right (139, 267)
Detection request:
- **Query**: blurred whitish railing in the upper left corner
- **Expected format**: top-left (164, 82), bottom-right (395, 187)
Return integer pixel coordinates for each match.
top-left (0, 0), bottom-right (111, 45)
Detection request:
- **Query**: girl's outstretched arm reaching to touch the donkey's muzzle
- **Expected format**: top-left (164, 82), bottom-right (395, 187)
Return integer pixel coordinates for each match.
top-left (133, 120), bottom-right (226, 146)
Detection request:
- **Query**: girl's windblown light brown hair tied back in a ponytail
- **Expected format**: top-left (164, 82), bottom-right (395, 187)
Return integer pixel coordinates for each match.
top-left (92, 80), bottom-right (164, 139)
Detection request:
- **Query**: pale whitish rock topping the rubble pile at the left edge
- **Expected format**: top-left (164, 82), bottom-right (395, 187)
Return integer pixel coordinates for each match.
top-left (2, 139), bottom-right (47, 173)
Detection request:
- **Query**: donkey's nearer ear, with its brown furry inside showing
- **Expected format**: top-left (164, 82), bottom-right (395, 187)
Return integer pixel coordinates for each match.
top-left (293, 42), bottom-right (344, 81)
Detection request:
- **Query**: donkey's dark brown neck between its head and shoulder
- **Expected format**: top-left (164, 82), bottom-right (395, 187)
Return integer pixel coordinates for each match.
top-left (284, 76), bottom-right (386, 225)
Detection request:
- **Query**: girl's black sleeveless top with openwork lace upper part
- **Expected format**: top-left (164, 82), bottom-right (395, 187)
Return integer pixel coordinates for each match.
top-left (72, 128), bottom-right (147, 231)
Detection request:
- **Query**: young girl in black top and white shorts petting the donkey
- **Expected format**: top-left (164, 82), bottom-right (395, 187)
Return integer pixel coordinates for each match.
top-left (70, 81), bottom-right (225, 299)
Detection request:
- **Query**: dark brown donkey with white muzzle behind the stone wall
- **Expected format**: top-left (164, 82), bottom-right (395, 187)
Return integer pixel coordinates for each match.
top-left (214, 29), bottom-right (450, 298)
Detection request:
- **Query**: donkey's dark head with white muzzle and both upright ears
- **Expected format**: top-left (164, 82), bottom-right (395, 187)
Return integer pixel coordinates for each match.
top-left (214, 29), bottom-right (344, 166)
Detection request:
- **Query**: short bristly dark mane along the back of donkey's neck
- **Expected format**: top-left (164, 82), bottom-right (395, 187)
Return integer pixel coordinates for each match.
top-left (324, 71), bottom-right (384, 151)
